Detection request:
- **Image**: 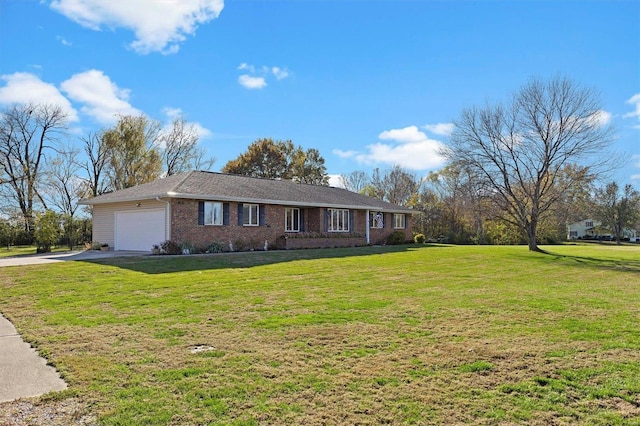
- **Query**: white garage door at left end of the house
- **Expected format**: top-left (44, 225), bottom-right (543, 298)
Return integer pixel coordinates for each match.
top-left (115, 209), bottom-right (166, 251)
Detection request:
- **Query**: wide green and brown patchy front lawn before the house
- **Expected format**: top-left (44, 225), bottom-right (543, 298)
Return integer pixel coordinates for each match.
top-left (0, 245), bottom-right (640, 425)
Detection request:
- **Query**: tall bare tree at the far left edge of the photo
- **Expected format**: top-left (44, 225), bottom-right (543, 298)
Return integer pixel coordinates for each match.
top-left (0, 104), bottom-right (68, 234)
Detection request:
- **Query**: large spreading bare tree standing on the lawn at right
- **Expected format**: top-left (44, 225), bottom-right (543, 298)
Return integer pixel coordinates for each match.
top-left (444, 77), bottom-right (613, 251)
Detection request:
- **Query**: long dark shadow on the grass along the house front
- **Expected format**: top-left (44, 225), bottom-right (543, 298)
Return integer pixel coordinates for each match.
top-left (80, 244), bottom-right (440, 274)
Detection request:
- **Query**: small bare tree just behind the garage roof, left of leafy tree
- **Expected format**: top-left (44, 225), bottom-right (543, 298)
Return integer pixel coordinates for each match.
top-left (159, 116), bottom-right (215, 176)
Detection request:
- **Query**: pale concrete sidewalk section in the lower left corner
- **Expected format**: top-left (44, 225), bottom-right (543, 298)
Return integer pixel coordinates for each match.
top-left (0, 315), bottom-right (67, 402)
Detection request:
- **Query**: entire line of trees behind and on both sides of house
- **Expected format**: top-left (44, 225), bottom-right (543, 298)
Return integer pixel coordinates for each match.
top-left (0, 77), bottom-right (640, 251)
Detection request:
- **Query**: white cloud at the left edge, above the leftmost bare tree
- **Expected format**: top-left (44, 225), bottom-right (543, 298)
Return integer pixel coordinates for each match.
top-left (0, 72), bottom-right (78, 121)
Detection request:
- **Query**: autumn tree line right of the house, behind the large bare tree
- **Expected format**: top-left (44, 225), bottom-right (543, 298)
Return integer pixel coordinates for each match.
top-left (340, 164), bottom-right (640, 245)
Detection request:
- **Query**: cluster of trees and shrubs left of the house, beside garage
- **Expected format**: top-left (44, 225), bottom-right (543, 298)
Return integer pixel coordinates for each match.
top-left (0, 103), bottom-right (215, 249)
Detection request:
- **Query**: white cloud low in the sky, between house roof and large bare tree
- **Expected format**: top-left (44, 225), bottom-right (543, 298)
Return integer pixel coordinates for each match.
top-left (333, 126), bottom-right (445, 170)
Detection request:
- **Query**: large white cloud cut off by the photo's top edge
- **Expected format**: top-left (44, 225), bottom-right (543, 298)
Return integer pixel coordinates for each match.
top-left (51, 0), bottom-right (224, 54)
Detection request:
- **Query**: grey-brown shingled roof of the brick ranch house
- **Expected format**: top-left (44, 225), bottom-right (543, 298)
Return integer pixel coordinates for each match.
top-left (81, 171), bottom-right (413, 213)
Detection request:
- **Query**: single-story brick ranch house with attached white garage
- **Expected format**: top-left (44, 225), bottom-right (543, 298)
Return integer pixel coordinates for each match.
top-left (81, 171), bottom-right (414, 251)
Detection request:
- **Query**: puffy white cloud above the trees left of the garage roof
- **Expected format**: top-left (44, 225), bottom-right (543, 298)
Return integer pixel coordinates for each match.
top-left (60, 70), bottom-right (141, 124)
